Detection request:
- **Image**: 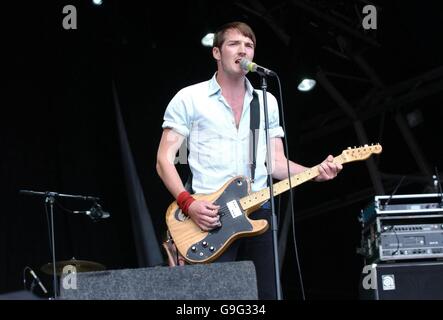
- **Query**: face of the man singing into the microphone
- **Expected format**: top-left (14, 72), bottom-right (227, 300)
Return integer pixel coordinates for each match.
top-left (212, 29), bottom-right (254, 75)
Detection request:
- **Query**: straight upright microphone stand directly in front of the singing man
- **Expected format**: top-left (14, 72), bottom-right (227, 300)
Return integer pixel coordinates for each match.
top-left (259, 72), bottom-right (282, 300)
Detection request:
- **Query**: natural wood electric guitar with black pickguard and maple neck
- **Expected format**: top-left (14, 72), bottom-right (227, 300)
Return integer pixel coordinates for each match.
top-left (166, 144), bottom-right (382, 263)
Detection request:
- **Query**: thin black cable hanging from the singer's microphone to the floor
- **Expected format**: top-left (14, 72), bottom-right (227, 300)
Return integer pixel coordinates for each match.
top-left (276, 75), bottom-right (306, 301)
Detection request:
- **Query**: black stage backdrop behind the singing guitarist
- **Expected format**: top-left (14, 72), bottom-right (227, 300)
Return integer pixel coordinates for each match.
top-left (0, 0), bottom-right (443, 299)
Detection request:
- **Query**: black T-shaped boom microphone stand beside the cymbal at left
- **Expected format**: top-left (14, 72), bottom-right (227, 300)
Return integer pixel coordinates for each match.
top-left (20, 190), bottom-right (100, 300)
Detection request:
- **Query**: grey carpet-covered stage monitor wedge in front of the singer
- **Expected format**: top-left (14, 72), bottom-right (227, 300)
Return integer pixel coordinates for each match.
top-left (60, 261), bottom-right (258, 300)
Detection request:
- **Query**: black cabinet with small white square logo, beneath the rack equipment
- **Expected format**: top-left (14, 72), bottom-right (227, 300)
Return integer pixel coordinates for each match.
top-left (360, 261), bottom-right (443, 300)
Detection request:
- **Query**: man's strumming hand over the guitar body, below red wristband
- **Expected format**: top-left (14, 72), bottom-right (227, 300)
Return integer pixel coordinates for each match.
top-left (188, 200), bottom-right (221, 231)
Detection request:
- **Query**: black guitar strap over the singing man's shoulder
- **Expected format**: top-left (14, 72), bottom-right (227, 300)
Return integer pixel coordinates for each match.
top-left (185, 90), bottom-right (260, 193)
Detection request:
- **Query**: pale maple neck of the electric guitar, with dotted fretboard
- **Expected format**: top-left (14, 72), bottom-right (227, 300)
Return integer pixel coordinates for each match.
top-left (240, 155), bottom-right (347, 210)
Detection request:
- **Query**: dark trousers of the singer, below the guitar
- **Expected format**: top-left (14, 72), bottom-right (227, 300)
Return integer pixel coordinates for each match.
top-left (217, 208), bottom-right (277, 300)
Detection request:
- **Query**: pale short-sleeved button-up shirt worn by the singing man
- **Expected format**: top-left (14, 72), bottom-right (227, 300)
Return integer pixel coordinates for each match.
top-left (162, 74), bottom-right (284, 194)
